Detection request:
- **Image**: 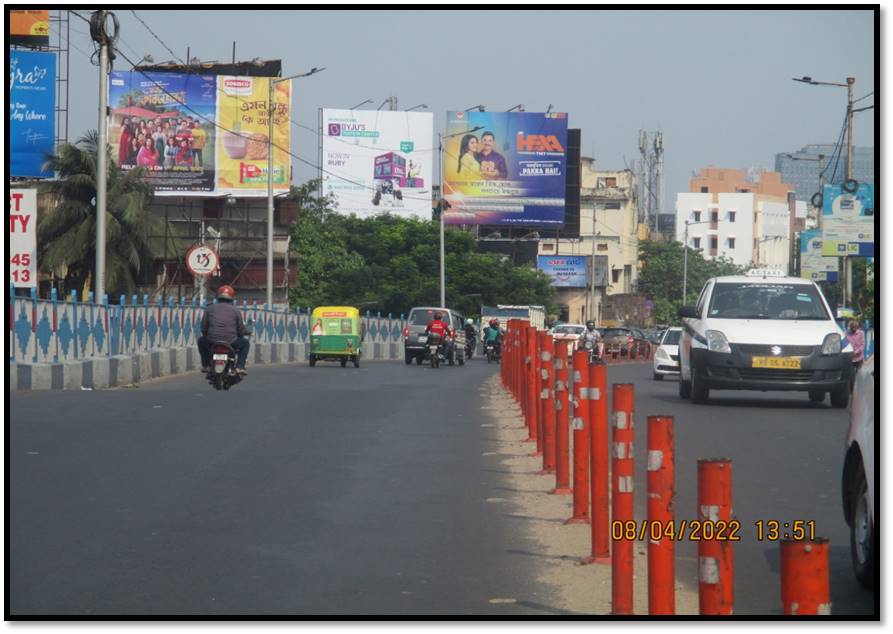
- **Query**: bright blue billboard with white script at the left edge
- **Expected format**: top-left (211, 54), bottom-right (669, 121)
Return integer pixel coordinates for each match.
top-left (8, 49), bottom-right (56, 178)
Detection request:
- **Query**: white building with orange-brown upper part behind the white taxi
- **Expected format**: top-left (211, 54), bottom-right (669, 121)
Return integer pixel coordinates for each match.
top-left (676, 167), bottom-right (805, 273)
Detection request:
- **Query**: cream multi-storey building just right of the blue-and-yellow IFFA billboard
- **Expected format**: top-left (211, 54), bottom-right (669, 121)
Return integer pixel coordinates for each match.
top-left (538, 156), bottom-right (639, 323)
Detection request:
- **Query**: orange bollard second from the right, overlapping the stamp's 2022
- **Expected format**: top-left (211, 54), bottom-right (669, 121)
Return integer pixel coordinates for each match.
top-left (698, 458), bottom-right (735, 615)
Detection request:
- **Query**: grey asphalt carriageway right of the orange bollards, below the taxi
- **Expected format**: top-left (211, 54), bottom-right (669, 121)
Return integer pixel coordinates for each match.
top-left (596, 364), bottom-right (874, 615)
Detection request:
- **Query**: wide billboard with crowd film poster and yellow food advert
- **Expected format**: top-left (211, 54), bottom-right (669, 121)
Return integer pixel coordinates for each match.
top-left (109, 71), bottom-right (291, 196)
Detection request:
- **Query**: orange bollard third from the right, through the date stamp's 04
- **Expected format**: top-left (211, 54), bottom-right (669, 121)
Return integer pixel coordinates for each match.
top-left (647, 416), bottom-right (676, 614)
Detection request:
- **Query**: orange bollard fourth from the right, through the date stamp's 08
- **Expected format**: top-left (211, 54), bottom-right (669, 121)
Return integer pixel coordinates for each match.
top-left (611, 383), bottom-right (638, 614)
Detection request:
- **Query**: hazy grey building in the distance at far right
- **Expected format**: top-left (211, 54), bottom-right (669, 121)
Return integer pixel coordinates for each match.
top-left (775, 144), bottom-right (874, 201)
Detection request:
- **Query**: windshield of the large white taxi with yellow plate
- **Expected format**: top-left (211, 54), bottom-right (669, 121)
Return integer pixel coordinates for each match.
top-left (707, 282), bottom-right (830, 320)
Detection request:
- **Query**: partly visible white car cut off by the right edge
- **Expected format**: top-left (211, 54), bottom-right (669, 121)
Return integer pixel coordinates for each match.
top-left (841, 356), bottom-right (877, 588)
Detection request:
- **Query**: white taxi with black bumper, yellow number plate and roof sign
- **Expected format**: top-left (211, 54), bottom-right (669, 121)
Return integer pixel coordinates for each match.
top-left (679, 270), bottom-right (852, 408)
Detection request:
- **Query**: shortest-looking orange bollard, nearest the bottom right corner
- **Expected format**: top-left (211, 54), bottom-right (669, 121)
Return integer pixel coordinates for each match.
top-left (781, 537), bottom-right (831, 616)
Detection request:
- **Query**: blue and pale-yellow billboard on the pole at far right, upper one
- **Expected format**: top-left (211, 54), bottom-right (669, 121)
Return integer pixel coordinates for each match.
top-left (822, 183), bottom-right (874, 257)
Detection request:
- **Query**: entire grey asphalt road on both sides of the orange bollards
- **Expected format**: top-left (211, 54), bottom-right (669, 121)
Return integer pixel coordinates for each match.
top-left (7, 359), bottom-right (873, 617)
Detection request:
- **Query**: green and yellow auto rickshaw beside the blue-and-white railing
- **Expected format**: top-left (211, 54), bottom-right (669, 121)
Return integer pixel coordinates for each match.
top-left (310, 306), bottom-right (363, 368)
